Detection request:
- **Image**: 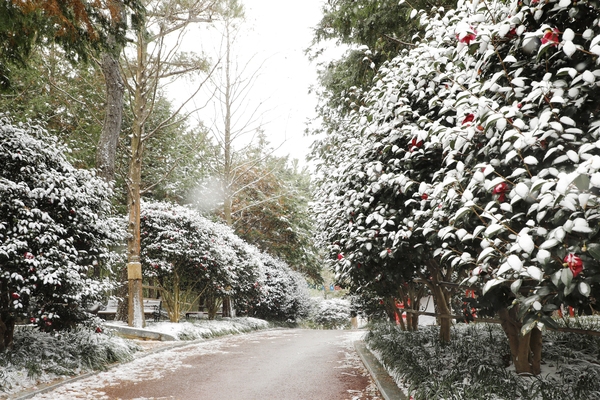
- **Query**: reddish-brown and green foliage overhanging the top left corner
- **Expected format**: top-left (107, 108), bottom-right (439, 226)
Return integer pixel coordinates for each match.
top-left (0, 0), bottom-right (143, 88)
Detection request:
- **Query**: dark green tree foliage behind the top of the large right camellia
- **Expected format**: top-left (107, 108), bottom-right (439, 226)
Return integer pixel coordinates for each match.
top-left (309, 0), bottom-right (456, 110)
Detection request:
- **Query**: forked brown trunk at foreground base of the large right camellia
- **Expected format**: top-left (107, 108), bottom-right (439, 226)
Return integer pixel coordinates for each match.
top-left (498, 307), bottom-right (542, 375)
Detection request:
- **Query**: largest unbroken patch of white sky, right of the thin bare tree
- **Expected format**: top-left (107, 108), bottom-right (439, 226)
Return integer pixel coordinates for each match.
top-left (240, 0), bottom-right (323, 161)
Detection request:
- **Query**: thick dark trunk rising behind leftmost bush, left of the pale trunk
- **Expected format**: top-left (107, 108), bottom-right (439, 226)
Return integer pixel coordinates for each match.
top-left (96, 53), bottom-right (125, 182)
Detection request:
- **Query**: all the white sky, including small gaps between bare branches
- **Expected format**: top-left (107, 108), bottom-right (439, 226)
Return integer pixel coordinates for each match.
top-left (169, 0), bottom-right (341, 165)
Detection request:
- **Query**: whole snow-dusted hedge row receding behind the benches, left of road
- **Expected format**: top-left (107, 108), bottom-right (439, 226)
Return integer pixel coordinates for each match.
top-left (141, 202), bottom-right (308, 321)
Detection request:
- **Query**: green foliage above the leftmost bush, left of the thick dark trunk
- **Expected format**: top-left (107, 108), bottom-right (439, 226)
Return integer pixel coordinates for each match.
top-left (0, 48), bottom-right (105, 169)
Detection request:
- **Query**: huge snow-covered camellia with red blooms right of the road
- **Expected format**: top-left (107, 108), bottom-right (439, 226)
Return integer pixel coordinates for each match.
top-left (316, 0), bottom-right (600, 374)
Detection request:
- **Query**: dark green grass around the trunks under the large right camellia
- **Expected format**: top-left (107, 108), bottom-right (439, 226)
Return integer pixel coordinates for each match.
top-left (366, 319), bottom-right (600, 400)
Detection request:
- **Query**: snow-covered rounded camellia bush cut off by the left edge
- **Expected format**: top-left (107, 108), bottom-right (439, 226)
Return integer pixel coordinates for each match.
top-left (0, 117), bottom-right (122, 350)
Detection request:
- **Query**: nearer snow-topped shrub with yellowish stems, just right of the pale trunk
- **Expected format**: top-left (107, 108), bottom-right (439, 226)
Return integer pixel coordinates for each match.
top-left (140, 202), bottom-right (258, 322)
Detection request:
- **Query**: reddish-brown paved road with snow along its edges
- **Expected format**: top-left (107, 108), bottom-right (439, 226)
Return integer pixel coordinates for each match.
top-left (28, 329), bottom-right (380, 400)
